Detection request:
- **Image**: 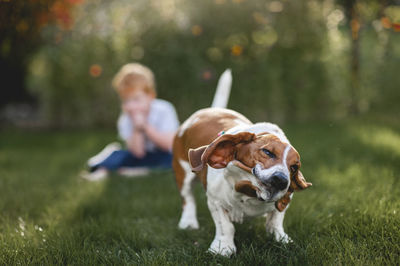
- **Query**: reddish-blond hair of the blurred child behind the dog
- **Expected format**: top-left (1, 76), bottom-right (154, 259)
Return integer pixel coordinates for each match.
top-left (112, 63), bottom-right (157, 99)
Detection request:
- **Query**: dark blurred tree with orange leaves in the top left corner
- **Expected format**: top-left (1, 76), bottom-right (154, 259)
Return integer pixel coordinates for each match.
top-left (0, 0), bottom-right (82, 106)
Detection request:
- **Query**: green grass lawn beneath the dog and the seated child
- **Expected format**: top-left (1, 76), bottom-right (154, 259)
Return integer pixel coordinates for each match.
top-left (0, 121), bottom-right (400, 265)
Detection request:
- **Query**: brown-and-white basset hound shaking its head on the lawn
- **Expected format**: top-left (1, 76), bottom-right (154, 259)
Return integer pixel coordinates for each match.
top-left (172, 70), bottom-right (312, 257)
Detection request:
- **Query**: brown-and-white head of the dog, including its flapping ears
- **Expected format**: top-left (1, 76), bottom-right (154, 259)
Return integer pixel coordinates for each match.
top-left (189, 132), bottom-right (311, 205)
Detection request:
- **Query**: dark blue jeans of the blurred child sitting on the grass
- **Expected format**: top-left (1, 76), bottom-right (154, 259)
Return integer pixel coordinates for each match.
top-left (90, 150), bottom-right (172, 171)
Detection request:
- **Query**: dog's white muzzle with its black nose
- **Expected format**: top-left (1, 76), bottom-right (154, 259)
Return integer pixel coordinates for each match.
top-left (252, 164), bottom-right (289, 190)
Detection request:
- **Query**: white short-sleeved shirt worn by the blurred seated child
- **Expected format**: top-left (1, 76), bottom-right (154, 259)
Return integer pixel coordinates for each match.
top-left (117, 99), bottom-right (179, 151)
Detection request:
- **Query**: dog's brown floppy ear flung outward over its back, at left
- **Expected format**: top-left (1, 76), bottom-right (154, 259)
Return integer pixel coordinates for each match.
top-left (188, 132), bottom-right (256, 172)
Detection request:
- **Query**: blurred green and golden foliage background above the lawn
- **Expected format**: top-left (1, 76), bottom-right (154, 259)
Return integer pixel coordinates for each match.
top-left (0, 0), bottom-right (400, 128)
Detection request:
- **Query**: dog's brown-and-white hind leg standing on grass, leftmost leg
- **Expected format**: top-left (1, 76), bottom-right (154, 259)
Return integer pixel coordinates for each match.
top-left (173, 160), bottom-right (199, 229)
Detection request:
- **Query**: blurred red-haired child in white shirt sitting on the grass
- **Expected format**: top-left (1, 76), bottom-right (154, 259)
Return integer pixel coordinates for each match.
top-left (82, 63), bottom-right (179, 181)
